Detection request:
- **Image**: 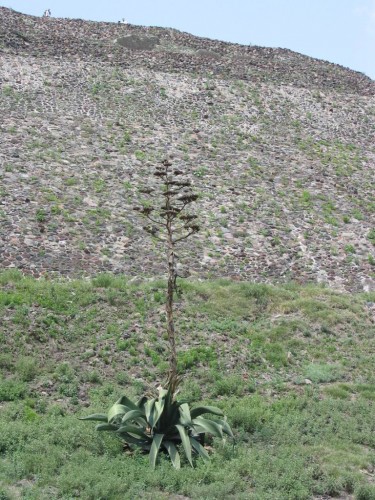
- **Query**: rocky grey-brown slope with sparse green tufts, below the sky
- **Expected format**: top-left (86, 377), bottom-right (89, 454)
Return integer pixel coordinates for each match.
top-left (0, 8), bottom-right (375, 290)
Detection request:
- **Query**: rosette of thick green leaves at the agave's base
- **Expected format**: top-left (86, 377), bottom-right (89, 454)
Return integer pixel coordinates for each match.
top-left (81, 387), bottom-right (234, 469)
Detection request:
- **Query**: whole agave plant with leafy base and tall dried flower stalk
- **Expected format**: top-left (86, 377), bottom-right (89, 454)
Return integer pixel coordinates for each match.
top-left (82, 159), bottom-right (233, 469)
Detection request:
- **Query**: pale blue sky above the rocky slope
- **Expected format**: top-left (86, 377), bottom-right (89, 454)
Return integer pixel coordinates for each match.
top-left (0, 0), bottom-right (375, 80)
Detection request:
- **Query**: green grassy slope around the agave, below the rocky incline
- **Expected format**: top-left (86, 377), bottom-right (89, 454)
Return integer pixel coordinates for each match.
top-left (0, 271), bottom-right (375, 500)
